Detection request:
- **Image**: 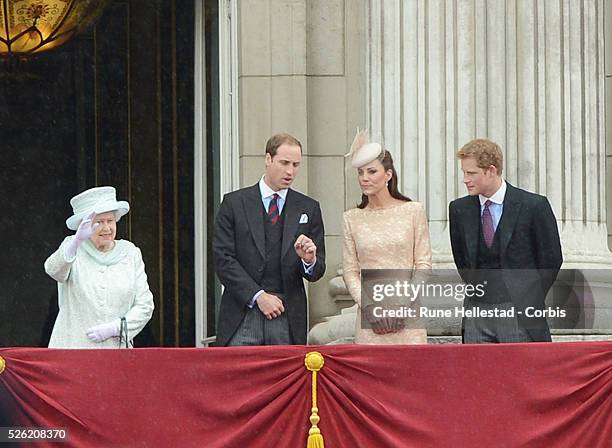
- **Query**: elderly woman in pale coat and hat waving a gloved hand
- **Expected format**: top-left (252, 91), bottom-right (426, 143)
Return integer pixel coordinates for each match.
top-left (45, 187), bottom-right (153, 348)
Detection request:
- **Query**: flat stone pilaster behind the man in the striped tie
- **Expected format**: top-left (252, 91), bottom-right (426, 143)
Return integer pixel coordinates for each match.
top-left (237, 0), bottom-right (309, 189)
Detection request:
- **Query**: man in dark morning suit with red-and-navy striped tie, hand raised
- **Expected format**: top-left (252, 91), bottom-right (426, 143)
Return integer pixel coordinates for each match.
top-left (213, 134), bottom-right (325, 345)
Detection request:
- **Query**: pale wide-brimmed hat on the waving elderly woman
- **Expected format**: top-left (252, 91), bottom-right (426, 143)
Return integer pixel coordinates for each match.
top-left (66, 187), bottom-right (130, 230)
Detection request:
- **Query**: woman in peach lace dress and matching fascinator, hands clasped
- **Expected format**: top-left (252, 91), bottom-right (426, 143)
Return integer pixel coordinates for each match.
top-left (343, 131), bottom-right (431, 344)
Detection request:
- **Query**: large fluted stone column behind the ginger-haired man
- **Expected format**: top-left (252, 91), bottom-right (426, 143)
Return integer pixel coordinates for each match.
top-left (367, 0), bottom-right (612, 267)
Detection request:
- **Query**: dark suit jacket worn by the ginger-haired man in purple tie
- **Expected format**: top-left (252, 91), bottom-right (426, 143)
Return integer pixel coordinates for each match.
top-left (449, 182), bottom-right (563, 341)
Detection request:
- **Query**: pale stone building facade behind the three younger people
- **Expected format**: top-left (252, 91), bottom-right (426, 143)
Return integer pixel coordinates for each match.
top-left (204, 0), bottom-right (612, 341)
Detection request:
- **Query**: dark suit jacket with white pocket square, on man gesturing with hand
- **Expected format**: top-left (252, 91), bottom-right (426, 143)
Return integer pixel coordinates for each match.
top-left (213, 184), bottom-right (325, 346)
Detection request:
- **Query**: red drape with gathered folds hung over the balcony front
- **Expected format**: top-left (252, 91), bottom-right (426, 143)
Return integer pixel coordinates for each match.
top-left (0, 342), bottom-right (612, 448)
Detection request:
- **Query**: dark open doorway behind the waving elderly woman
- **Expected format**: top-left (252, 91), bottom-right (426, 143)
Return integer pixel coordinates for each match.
top-left (0, 0), bottom-right (206, 346)
